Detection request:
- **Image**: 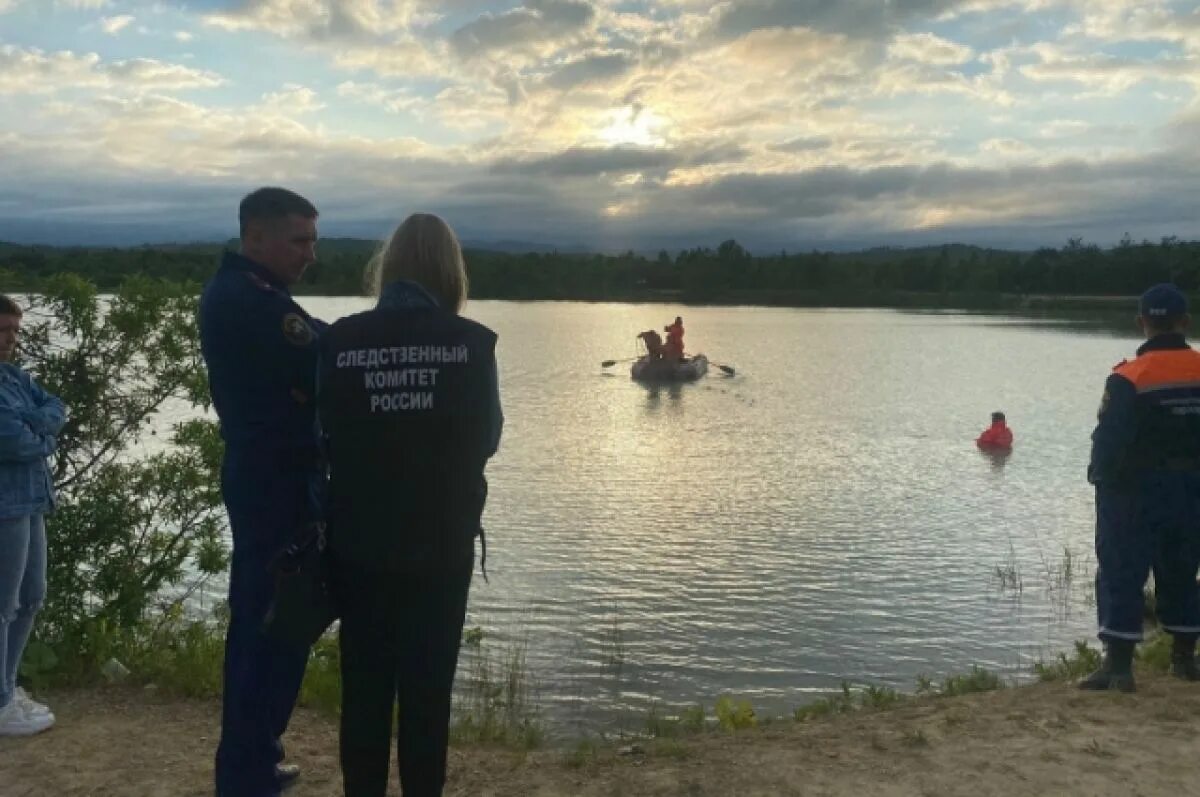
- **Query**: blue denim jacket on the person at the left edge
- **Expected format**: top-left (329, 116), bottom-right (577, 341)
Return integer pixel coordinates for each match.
top-left (0, 362), bottom-right (66, 519)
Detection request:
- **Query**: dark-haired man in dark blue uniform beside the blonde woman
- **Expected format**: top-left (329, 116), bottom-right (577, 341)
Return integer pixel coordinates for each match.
top-left (199, 188), bottom-right (325, 797)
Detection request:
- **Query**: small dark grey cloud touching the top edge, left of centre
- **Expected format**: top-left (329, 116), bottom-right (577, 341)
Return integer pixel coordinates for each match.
top-left (450, 0), bottom-right (595, 58)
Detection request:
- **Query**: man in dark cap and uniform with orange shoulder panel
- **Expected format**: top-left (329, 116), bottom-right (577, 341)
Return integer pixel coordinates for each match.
top-left (1080, 283), bottom-right (1200, 691)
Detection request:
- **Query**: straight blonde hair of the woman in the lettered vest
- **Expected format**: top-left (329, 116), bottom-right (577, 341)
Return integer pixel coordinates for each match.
top-left (366, 214), bottom-right (467, 313)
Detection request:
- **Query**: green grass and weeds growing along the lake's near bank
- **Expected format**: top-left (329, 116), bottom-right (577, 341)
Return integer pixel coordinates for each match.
top-left (37, 604), bottom-right (1171, 767)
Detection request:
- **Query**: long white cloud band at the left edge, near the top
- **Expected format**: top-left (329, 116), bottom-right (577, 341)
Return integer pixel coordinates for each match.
top-left (0, 44), bottom-right (224, 94)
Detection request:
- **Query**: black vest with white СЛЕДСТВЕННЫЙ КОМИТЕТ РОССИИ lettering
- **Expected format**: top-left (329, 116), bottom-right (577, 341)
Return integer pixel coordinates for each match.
top-left (318, 292), bottom-right (499, 573)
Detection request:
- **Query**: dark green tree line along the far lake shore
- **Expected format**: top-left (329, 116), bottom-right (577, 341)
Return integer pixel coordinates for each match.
top-left (0, 236), bottom-right (1200, 306)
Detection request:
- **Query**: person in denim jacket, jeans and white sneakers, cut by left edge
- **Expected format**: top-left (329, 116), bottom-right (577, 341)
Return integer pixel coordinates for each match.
top-left (0, 295), bottom-right (65, 736)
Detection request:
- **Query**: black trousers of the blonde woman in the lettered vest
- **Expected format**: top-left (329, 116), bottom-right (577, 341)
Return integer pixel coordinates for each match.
top-left (335, 556), bottom-right (474, 797)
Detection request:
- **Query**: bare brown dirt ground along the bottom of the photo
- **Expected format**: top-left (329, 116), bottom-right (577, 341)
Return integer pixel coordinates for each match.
top-left (0, 676), bottom-right (1200, 797)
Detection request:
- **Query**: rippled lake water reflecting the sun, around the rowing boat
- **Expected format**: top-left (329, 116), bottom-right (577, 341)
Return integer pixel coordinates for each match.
top-left (216, 298), bottom-right (1138, 730)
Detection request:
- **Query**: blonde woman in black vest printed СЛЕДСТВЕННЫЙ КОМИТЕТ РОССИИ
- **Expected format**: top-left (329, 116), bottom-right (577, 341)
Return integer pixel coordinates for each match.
top-left (317, 214), bottom-right (503, 797)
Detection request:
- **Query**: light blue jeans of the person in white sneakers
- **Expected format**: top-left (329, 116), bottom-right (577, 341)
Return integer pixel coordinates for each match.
top-left (0, 515), bottom-right (46, 708)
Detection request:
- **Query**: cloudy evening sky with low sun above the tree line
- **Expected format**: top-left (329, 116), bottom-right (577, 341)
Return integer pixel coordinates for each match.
top-left (0, 0), bottom-right (1200, 251)
